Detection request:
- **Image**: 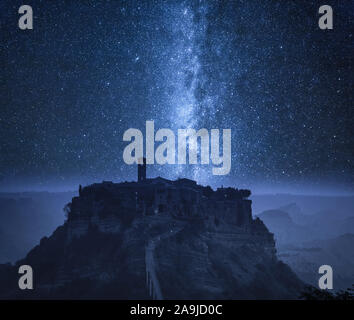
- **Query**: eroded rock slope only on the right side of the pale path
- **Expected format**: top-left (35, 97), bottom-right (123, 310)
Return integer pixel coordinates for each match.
top-left (156, 219), bottom-right (302, 299)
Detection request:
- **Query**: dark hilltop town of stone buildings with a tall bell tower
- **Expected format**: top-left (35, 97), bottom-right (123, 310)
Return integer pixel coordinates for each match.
top-left (68, 159), bottom-right (263, 238)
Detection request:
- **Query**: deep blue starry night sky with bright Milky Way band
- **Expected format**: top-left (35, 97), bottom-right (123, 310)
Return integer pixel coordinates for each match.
top-left (0, 0), bottom-right (354, 193)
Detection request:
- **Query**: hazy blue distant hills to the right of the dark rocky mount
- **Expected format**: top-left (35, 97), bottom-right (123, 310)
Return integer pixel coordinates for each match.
top-left (254, 198), bottom-right (354, 289)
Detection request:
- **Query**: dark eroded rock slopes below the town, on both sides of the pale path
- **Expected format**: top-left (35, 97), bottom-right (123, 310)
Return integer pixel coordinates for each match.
top-left (0, 218), bottom-right (302, 299)
